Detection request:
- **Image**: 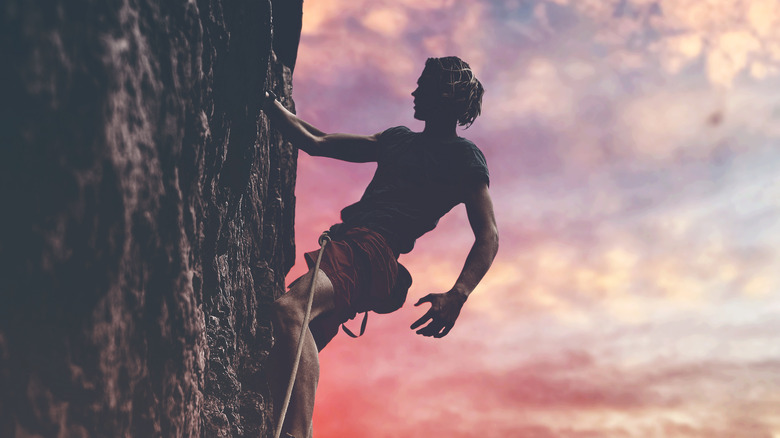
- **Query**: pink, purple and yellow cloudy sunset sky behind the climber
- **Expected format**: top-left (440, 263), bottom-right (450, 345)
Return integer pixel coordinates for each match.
top-left (280, 0), bottom-right (780, 438)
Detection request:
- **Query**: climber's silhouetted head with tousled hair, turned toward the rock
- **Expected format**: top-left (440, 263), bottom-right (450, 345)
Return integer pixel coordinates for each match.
top-left (412, 56), bottom-right (485, 126)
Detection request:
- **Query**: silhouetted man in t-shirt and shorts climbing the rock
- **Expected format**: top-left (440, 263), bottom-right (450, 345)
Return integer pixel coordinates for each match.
top-left (264, 57), bottom-right (498, 438)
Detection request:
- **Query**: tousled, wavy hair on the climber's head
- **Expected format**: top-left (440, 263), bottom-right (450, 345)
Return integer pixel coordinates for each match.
top-left (425, 56), bottom-right (485, 128)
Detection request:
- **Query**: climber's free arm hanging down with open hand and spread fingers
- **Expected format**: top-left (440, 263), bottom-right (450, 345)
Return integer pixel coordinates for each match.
top-left (411, 182), bottom-right (498, 338)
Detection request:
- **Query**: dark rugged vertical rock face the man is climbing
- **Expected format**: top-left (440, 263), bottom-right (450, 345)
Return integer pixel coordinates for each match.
top-left (0, 0), bottom-right (301, 437)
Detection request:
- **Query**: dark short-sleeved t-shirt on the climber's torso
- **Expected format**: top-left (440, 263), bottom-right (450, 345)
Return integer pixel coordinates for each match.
top-left (341, 126), bottom-right (490, 254)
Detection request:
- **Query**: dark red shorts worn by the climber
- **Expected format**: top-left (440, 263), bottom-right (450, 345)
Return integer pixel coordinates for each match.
top-left (304, 228), bottom-right (398, 350)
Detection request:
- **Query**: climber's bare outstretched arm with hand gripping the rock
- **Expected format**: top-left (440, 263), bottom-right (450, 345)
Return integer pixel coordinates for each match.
top-left (263, 94), bottom-right (379, 163)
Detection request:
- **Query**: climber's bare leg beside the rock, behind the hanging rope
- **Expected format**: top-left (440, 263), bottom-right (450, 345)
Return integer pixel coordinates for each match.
top-left (269, 271), bottom-right (335, 438)
